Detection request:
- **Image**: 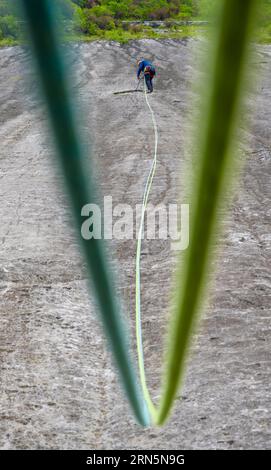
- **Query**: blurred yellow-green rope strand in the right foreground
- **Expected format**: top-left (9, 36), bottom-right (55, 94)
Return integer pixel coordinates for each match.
top-left (158, 0), bottom-right (256, 424)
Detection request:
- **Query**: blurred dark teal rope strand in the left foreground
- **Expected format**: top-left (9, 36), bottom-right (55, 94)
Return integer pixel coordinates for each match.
top-left (21, 0), bottom-right (149, 425)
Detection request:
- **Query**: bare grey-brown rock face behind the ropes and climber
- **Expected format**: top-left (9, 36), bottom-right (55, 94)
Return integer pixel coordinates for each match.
top-left (0, 40), bottom-right (271, 449)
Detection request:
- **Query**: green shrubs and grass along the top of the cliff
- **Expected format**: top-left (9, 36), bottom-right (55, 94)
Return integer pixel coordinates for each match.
top-left (0, 0), bottom-right (271, 45)
